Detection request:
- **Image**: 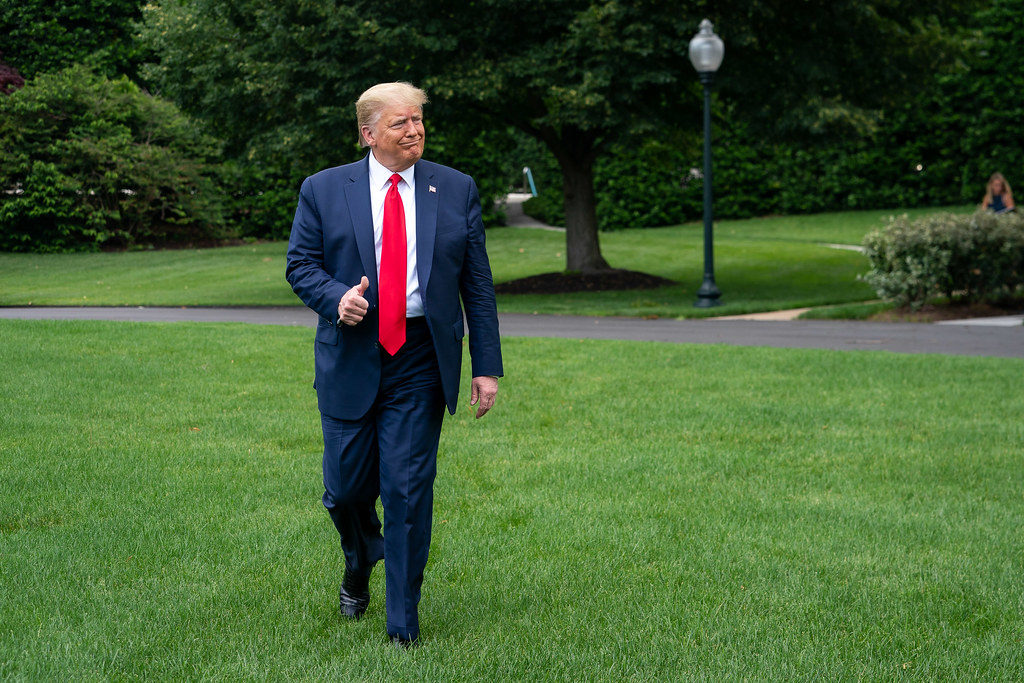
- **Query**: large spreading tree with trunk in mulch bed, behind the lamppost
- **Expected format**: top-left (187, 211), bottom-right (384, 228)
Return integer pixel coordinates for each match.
top-left (145, 0), bottom-right (973, 271)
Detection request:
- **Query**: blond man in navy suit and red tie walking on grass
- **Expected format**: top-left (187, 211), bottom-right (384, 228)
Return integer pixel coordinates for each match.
top-left (287, 83), bottom-right (503, 646)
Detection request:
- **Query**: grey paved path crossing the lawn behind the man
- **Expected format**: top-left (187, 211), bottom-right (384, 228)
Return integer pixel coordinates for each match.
top-left (0, 306), bottom-right (1024, 358)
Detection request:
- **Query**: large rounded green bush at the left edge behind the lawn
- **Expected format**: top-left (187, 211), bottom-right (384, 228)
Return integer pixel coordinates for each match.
top-left (0, 67), bottom-right (223, 251)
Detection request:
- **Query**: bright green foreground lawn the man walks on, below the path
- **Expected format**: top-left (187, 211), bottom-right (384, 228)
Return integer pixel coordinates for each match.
top-left (0, 321), bottom-right (1024, 681)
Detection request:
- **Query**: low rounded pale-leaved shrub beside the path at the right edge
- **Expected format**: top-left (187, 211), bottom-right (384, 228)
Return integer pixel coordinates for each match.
top-left (862, 212), bottom-right (1024, 308)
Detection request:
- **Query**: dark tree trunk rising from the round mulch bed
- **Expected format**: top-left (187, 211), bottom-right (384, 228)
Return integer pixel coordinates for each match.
top-left (560, 154), bottom-right (610, 272)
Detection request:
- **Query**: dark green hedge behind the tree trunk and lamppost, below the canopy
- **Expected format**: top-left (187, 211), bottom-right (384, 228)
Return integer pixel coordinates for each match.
top-left (524, 101), bottom-right (983, 230)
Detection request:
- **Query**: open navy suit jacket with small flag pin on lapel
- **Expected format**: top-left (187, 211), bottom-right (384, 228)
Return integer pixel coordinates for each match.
top-left (286, 157), bottom-right (503, 420)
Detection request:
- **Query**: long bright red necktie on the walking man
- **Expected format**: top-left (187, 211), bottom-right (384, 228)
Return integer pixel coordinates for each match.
top-left (379, 173), bottom-right (409, 355)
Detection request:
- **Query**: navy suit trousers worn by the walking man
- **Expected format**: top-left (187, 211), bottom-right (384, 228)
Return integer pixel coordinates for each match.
top-left (321, 317), bottom-right (444, 639)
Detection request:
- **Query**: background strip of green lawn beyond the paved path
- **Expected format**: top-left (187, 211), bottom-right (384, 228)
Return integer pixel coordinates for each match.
top-left (0, 208), bottom-right (967, 317)
